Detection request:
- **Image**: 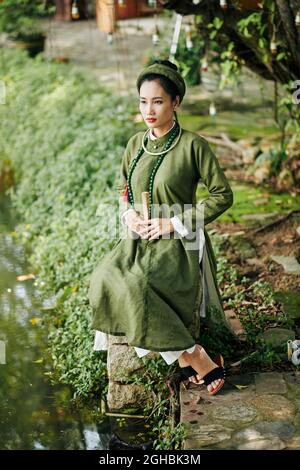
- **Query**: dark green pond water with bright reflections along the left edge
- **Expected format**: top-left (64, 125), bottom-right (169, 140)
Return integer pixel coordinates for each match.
top-left (0, 198), bottom-right (111, 450)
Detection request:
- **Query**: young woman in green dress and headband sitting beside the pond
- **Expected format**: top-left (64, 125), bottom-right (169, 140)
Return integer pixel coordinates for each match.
top-left (89, 60), bottom-right (233, 394)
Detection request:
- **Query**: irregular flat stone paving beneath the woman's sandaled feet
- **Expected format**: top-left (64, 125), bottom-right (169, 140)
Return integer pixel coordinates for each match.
top-left (180, 370), bottom-right (300, 450)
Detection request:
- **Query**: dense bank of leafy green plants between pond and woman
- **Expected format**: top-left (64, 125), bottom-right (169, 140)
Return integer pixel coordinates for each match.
top-left (0, 50), bottom-right (134, 396)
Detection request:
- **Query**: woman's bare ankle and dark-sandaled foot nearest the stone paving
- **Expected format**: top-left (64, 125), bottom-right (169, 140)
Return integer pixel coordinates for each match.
top-left (180, 344), bottom-right (225, 395)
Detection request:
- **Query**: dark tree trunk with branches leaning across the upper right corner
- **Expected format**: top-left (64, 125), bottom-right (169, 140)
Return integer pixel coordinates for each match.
top-left (159, 0), bottom-right (300, 83)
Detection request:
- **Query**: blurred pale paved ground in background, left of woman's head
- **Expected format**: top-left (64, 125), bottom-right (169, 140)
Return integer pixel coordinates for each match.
top-left (45, 17), bottom-right (172, 94)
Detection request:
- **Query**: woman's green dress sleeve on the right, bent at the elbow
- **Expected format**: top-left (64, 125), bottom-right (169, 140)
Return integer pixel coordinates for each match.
top-left (176, 139), bottom-right (233, 232)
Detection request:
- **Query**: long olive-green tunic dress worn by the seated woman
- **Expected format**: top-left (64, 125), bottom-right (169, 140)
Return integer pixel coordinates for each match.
top-left (88, 125), bottom-right (233, 352)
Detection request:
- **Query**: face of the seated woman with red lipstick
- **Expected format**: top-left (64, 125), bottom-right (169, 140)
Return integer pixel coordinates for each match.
top-left (139, 80), bottom-right (179, 132)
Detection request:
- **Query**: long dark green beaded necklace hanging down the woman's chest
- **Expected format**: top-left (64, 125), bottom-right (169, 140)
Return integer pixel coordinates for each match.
top-left (127, 123), bottom-right (181, 218)
